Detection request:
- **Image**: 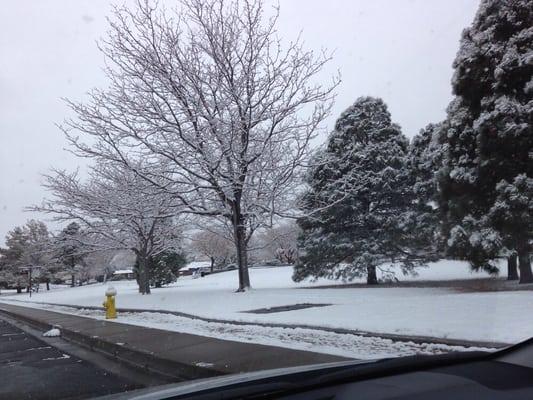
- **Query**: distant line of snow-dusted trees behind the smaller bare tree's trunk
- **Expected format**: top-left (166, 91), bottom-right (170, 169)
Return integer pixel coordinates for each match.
top-left (0, 220), bottom-right (186, 293)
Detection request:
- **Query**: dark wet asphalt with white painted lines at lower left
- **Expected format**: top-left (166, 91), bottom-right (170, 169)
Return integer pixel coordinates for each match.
top-left (0, 318), bottom-right (141, 400)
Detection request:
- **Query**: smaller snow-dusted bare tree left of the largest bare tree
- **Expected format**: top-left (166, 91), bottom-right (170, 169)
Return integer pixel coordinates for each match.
top-left (31, 163), bottom-right (181, 294)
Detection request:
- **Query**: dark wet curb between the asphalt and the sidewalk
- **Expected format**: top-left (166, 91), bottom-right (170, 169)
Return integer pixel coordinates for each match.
top-left (0, 305), bottom-right (225, 382)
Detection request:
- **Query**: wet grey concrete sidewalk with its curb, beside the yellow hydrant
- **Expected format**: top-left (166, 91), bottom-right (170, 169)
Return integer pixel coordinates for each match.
top-left (0, 303), bottom-right (347, 380)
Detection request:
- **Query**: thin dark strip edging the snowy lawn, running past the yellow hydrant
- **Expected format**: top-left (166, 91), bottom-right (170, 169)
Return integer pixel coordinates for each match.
top-left (1, 299), bottom-right (511, 349)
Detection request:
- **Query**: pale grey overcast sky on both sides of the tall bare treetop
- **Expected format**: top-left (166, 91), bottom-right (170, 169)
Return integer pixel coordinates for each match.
top-left (0, 0), bottom-right (479, 245)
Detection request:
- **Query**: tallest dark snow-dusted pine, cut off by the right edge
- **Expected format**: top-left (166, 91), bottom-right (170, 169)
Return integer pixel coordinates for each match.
top-left (439, 0), bottom-right (533, 282)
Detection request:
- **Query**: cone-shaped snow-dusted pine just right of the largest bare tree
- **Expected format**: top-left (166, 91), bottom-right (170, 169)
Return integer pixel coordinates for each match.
top-left (293, 97), bottom-right (432, 284)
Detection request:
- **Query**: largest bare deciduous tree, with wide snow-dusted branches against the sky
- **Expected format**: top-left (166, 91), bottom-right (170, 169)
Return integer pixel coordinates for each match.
top-left (62, 0), bottom-right (338, 291)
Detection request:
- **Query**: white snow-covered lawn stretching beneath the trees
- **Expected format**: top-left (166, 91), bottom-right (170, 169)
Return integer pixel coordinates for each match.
top-left (0, 261), bottom-right (533, 352)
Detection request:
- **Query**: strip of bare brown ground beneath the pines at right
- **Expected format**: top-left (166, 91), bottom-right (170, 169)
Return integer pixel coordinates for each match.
top-left (304, 278), bottom-right (533, 292)
